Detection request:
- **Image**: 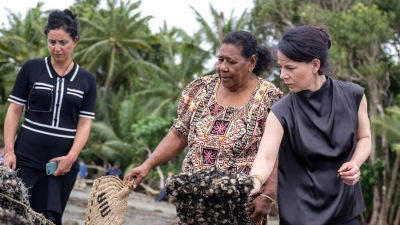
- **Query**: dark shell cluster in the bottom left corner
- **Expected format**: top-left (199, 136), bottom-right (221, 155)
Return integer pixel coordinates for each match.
top-left (0, 164), bottom-right (54, 225)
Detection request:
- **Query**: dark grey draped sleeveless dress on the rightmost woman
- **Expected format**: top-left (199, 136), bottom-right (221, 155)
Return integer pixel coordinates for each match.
top-left (271, 77), bottom-right (365, 225)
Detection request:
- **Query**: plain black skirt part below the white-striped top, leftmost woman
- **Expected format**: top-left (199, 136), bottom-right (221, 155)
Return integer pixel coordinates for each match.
top-left (15, 127), bottom-right (79, 215)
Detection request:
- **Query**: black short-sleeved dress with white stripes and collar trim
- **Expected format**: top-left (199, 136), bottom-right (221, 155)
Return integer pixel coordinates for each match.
top-left (8, 57), bottom-right (96, 215)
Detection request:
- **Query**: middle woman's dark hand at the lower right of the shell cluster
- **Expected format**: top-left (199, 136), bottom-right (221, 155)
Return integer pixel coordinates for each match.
top-left (249, 195), bottom-right (272, 223)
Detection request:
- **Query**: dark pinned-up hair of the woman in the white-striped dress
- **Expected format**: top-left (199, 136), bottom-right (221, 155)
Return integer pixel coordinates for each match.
top-left (44, 9), bottom-right (79, 39)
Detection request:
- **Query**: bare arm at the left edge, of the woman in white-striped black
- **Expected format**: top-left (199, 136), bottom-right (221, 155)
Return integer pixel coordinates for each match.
top-left (4, 102), bottom-right (24, 170)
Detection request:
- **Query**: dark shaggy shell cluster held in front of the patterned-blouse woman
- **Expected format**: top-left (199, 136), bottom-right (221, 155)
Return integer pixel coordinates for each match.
top-left (166, 167), bottom-right (253, 225)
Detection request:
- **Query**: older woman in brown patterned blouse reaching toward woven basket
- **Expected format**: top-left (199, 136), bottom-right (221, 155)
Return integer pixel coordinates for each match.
top-left (124, 31), bottom-right (283, 224)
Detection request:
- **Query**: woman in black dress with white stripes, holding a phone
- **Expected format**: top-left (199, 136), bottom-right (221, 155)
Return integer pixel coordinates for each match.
top-left (4, 9), bottom-right (96, 224)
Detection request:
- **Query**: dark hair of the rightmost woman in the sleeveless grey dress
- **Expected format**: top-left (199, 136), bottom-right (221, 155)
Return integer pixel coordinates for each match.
top-left (276, 25), bottom-right (331, 75)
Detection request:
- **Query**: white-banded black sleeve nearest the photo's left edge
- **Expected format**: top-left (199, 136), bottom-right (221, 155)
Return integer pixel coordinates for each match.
top-left (8, 62), bottom-right (30, 106)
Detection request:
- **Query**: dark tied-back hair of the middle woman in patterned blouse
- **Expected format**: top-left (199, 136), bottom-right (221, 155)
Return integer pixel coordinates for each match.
top-left (222, 31), bottom-right (272, 76)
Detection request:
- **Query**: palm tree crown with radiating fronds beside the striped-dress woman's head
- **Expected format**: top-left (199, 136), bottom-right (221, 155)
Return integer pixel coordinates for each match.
top-left (75, 0), bottom-right (154, 99)
